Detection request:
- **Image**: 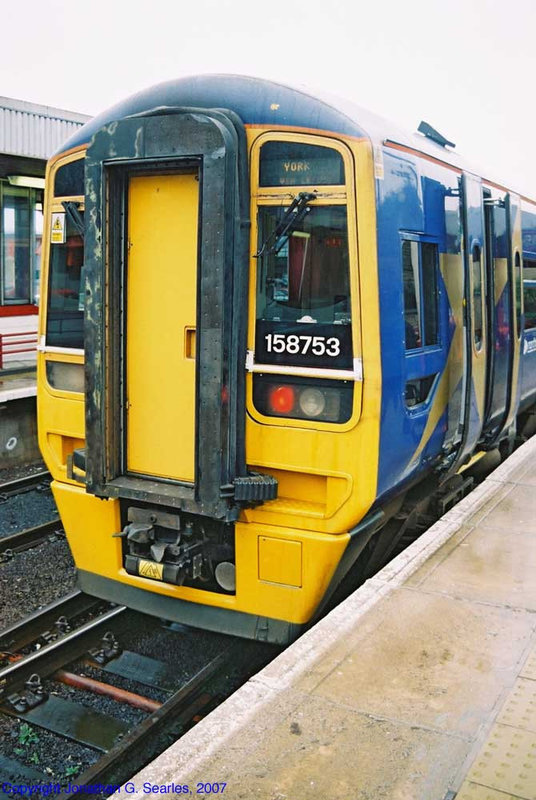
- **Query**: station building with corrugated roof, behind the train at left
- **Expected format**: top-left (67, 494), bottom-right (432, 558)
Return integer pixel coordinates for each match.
top-left (0, 97), bottom-right (89, 368)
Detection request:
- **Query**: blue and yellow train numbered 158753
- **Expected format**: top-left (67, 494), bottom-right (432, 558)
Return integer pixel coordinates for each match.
top-left (38, 75), bottom-right (536, 645)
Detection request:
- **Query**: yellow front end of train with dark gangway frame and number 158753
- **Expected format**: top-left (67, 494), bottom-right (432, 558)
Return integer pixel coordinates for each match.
top-left (38, 97), bottom-right (381, 643)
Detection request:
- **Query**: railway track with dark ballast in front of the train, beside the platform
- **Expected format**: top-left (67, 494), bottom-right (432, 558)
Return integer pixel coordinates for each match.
top-left (0, 591), bottom-right (249, 797)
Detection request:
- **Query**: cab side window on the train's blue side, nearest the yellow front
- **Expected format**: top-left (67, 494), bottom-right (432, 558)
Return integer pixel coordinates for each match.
top-left (402, 239), bottom-right (438, 350)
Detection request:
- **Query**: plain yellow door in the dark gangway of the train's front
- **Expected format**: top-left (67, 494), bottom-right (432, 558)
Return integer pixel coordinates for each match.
top-left (126, 170), bottom-right (199, 483)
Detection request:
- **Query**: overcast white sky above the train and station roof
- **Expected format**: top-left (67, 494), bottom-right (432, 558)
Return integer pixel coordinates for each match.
top-left (0, 0), bottom-right (536, 196)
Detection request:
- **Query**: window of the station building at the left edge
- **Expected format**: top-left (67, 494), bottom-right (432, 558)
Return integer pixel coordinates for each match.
top-left (0, 183), bottom-right (43, 305)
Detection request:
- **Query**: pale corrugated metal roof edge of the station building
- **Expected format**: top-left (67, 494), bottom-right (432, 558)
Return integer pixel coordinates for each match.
top-left (0, 97), bottom-right (90, 159)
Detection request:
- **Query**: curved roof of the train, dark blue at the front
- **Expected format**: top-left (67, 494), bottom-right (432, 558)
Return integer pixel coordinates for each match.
top-left (55, 74), bottom-right (528, 202)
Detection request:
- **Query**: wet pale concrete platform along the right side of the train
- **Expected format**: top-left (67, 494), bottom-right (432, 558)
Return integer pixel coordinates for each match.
top-left (121, 437), bottom-right (536, 800)
